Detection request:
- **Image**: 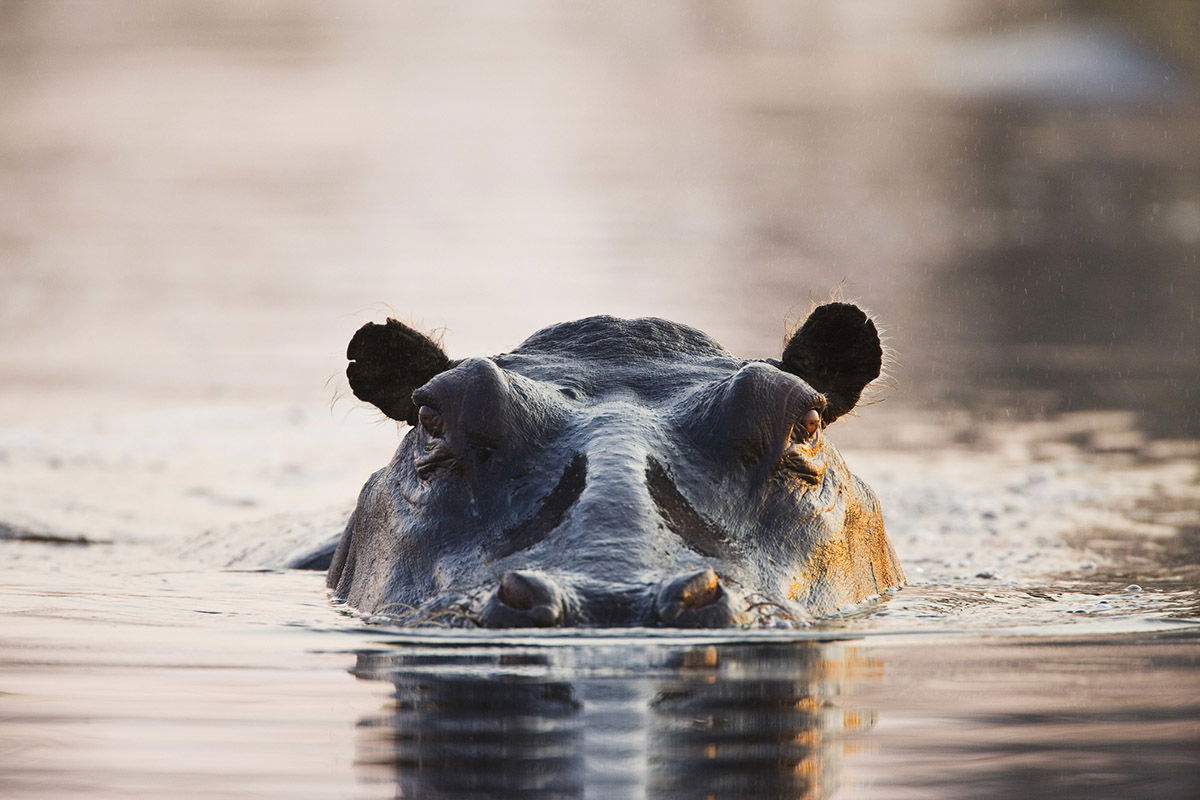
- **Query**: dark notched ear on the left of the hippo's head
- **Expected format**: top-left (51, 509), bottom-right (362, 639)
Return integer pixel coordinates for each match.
top-left (346, 318), bottom-right (450, 425)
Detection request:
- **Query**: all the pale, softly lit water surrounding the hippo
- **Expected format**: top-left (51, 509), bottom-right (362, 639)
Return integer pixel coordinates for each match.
top-left (0, 0), bottom-right (1200, 800)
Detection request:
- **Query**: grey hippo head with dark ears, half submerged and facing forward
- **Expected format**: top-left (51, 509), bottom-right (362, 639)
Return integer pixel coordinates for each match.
top-left (328, 302), bottom-right (904, 628)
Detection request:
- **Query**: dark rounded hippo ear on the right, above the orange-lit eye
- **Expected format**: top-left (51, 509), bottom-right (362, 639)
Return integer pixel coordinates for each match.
top-left (780, 302), bottom-right (883, 425)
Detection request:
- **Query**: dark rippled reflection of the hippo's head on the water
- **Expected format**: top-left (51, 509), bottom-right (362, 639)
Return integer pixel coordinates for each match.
top-left (354, 642), bottom-right (880, 798)
